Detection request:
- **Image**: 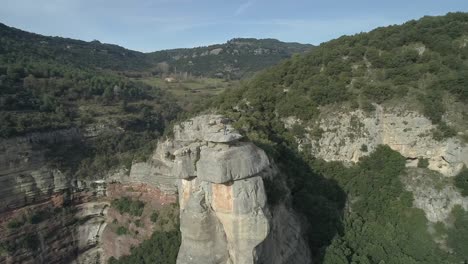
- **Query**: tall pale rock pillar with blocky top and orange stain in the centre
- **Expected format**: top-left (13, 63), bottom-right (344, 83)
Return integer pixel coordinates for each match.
top-left (155, 115), bottom-right (310, 264)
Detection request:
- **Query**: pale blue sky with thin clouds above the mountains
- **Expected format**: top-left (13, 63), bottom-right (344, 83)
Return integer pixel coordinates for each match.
top-left (0, 0), bottom-right (468, 52)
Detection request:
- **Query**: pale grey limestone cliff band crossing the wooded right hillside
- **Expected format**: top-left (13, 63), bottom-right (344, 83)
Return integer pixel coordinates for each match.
top-left (309, 106), bottom-right (468, 176)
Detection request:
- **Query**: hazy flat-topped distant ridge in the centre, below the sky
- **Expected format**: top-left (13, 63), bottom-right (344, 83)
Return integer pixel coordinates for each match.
top-left (149, 38), bottom-right (313, 79)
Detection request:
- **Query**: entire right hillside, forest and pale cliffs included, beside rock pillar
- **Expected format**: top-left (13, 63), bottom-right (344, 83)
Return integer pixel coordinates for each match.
top-left (212, 13), bottom-right (468, 263)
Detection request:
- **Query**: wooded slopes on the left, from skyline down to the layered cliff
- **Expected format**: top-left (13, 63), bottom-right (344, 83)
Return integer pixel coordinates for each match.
top-left (0, 20), bottom-right (186, 178)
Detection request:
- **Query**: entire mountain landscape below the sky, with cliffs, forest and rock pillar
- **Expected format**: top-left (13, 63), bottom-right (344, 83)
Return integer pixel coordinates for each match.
top-left (0, 12), bottom-right (468, 264)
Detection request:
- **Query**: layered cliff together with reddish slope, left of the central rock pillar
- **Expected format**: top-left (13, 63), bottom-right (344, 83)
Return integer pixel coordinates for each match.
top-left (0, 129), bottom-right (177, 264)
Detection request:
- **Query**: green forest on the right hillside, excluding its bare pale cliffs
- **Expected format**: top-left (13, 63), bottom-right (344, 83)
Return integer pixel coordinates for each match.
top-left (212, 13), bottom-right (468, 264)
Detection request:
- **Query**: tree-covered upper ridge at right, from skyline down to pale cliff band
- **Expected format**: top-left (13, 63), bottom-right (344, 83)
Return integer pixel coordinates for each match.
top-left (216, 13), bottom-right (468, 132)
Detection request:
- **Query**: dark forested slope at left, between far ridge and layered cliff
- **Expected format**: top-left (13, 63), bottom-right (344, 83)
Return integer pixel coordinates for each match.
top-left (0, 54), bottom-right (178, 137)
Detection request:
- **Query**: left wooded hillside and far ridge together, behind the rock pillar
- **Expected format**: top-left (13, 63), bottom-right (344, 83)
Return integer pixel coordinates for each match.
top-left (0, 24), bottom-right (309, 179)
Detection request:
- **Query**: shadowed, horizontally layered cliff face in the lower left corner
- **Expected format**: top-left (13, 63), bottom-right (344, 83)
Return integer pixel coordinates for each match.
top-left (0, 129), bottom-right (106, 263)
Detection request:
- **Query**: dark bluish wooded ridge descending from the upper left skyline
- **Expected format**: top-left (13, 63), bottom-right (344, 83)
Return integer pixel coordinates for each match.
top-left (0, 23), bottom-right (151, 71)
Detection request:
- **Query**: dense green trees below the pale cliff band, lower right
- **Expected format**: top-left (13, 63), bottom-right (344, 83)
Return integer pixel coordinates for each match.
top-left (313, 147), bottom-right (458, 263)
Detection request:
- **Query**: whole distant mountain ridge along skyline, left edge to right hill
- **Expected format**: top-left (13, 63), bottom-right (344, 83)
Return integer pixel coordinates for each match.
top-left (0, 23), bottom-right (313, 79)
